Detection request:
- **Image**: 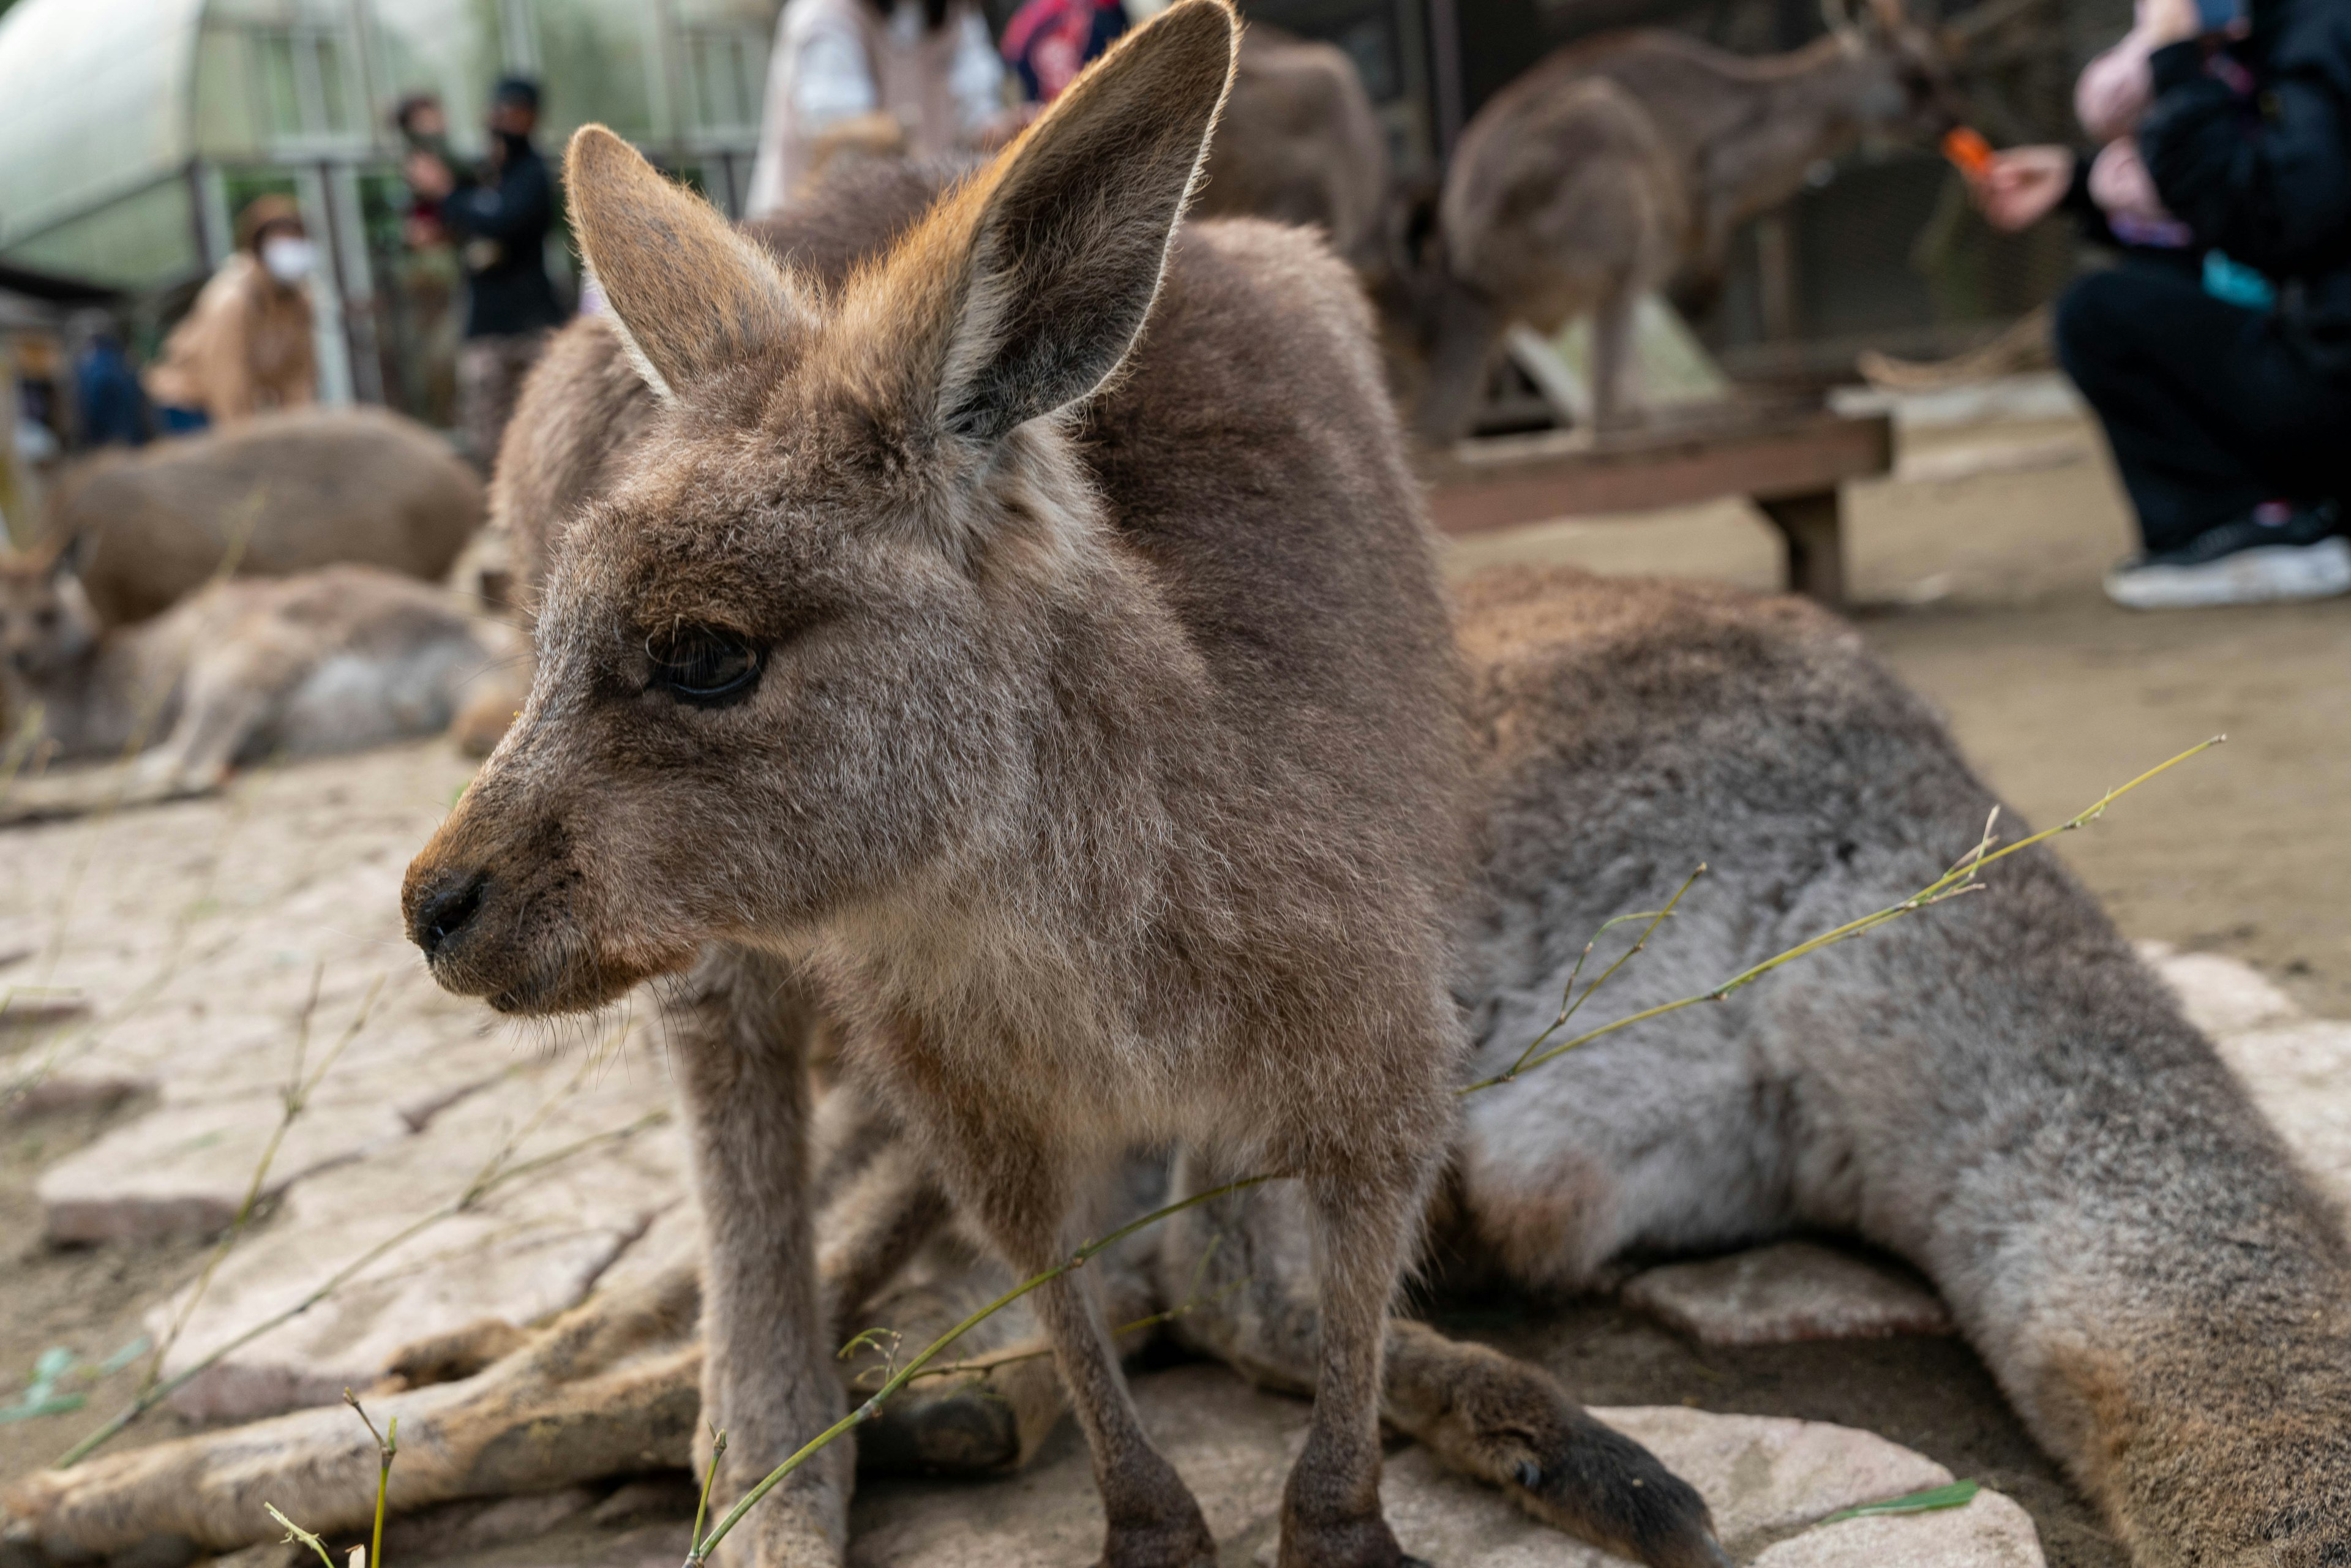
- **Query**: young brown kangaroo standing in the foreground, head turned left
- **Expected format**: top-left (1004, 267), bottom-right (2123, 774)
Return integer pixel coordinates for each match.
top-left (404, 0), bottom-right (1464, 1568)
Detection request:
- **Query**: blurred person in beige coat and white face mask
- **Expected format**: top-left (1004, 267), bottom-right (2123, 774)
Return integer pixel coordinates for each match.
top-left (146, 195), bottom-right (317, 435)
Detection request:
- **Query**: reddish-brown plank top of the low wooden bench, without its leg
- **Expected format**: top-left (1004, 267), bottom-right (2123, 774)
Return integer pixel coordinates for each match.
top-left (1425, 409), bottom-right (1892, 534)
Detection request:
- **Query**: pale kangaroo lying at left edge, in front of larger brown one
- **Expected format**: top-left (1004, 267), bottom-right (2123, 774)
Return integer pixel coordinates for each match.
top-left (0, 552), bottom-right (520, 823)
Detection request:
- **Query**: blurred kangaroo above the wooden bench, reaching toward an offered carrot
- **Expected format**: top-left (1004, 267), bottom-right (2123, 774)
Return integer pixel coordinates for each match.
top-left (1382, 0), bottom-right (1951, 442)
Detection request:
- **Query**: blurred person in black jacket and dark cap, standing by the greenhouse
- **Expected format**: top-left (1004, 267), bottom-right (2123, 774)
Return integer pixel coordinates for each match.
top-left (402, 75), bottom-right (564, 470)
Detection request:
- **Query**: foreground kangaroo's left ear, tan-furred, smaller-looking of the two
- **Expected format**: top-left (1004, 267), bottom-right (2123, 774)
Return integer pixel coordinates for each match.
top-left (564, 124), bottom-right (792, 404)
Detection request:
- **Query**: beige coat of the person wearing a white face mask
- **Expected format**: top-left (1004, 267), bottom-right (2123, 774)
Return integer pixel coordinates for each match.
top-left (146, 252), bottom-right (317, 426)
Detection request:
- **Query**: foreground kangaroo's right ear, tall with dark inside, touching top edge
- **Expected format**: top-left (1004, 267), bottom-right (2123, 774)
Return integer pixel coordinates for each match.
top-left (915, 0), bottom-right (1239, 440)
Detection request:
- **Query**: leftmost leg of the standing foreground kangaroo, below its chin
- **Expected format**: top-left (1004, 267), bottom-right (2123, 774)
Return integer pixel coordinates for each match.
top-left (666, 945), bottom-right (853, 1568)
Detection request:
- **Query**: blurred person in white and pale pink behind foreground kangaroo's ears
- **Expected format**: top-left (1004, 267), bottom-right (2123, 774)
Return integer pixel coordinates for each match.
top-left (743, 0), bottom-right (1025, 219)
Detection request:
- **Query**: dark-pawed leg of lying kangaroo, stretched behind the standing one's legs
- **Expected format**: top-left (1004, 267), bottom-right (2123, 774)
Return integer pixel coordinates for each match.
top-left (1159, 1173), bottom-right (1726, 1568)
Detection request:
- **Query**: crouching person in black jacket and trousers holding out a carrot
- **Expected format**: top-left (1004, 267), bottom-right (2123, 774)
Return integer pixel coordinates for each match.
top-left (1984, 0), bottom-right (2351, 609)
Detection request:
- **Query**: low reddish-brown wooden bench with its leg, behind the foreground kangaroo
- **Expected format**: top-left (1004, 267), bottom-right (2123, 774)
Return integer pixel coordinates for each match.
top-left (1422, 404), bottom-right (1895, 604)
